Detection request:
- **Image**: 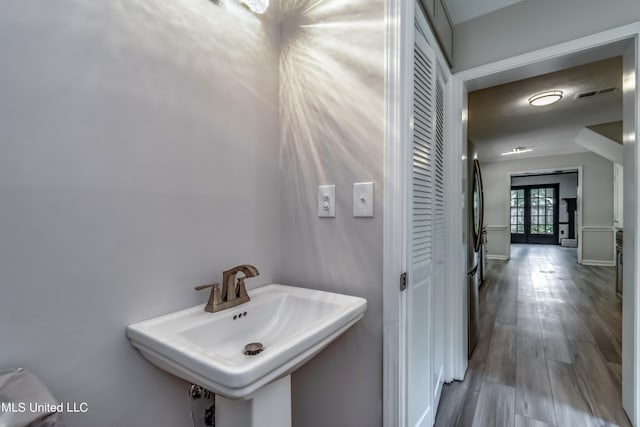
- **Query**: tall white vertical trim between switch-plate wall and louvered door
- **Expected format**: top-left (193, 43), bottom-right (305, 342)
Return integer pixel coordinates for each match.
top-left (382, 1), bottom-right (413, 427)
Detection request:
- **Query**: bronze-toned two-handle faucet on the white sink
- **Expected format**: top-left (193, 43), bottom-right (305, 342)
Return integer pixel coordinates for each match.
top-left (196, 264), bottom-right (260, 313)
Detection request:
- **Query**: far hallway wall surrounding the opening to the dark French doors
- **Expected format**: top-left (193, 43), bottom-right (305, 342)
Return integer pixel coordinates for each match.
top-left (482, 153), bottom-right (613, 263)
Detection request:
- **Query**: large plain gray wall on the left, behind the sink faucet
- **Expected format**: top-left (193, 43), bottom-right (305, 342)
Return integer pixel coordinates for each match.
top-left (0, 0), bottom-right (280, 427)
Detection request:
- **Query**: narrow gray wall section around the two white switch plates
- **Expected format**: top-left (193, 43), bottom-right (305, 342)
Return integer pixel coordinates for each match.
top-left (279, 0), bottom-right (385, 427)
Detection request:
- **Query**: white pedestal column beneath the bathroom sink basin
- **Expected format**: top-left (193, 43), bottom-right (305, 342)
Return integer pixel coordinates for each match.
top-left (216, 375), bottom-right (291, 427)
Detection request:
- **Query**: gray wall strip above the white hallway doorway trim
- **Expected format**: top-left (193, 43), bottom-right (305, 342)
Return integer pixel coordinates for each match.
top-left (453, 0), bottom-right (640, 71)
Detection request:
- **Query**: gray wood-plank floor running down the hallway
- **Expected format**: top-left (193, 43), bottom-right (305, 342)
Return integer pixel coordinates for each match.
top-left (436, 245), bottom-right (631, 427)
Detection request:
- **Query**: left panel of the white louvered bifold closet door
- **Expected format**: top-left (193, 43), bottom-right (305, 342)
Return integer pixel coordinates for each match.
top-left (406, 31), bottom-right (436, 427)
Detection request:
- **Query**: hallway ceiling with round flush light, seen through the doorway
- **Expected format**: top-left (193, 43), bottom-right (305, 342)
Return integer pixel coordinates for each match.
top-left (468, 56), bottom-right (622, 161)
